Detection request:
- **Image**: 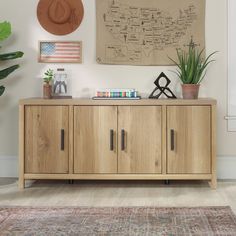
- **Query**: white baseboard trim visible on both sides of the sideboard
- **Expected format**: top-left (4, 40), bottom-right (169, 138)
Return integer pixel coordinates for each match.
top-left (0, 156), bottom-right (236, 180)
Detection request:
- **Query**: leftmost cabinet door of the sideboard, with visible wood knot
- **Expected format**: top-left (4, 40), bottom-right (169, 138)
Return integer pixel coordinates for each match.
top-left (25, 106), bottom-right (69, 174)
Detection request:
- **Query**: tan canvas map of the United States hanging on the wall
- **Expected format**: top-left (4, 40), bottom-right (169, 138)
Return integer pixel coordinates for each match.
top-left (96, 0), bottom-right (205, 65)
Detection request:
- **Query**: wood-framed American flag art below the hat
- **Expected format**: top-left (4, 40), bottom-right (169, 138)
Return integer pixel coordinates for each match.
top-left (38, 41), bottom-right (82, 63)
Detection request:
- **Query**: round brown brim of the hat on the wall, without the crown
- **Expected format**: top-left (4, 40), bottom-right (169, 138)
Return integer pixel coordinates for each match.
top-left (37, 0), bottom-right (84, 35)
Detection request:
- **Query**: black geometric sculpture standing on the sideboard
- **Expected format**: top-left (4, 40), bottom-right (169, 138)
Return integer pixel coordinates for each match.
top-left (149, 72), bottom-right (177, 99)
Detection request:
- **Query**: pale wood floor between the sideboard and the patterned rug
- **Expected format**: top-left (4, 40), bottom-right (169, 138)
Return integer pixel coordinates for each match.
top-left (0, 178), bottom-right (236, 213)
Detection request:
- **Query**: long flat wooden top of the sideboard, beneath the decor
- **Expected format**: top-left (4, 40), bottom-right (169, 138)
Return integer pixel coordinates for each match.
top-left (19, 98), bottom-right (216, 106)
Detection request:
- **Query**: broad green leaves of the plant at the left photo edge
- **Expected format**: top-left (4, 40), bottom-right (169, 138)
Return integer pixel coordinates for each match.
top-left (0, 21), bottom-right (24, 96)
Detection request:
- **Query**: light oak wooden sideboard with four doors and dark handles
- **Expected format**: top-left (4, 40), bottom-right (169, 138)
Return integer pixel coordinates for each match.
top-left (19, 98), bottom-right (217, 188)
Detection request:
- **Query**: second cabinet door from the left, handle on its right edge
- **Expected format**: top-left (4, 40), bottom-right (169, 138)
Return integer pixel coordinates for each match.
top-left (74, 106), bottom-right (117, 174)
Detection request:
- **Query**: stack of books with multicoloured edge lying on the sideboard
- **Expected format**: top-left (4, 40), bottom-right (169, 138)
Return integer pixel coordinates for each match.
top-left (93, 89), bottom-right (140, 99)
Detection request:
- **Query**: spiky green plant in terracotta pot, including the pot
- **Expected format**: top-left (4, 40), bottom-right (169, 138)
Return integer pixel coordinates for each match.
top-left (170, 39), bottom-right (216, 99)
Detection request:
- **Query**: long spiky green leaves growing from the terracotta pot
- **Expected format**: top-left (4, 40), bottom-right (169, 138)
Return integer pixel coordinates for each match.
top-left (169, 39), bottom-right (217, 84)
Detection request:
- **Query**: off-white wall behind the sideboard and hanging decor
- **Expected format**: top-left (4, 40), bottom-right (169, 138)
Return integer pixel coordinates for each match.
top-left (0, 0), bottom-right (236, 175)
